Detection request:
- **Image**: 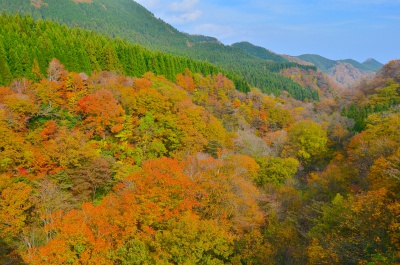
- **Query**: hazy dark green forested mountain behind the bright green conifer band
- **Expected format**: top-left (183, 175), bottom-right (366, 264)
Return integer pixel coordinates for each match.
top-left (0, 0), bottom-right (318, 100)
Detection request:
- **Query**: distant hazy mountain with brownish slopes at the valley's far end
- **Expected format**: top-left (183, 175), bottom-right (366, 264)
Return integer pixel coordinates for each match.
top-left (297, 54), bottom-right (383, 86)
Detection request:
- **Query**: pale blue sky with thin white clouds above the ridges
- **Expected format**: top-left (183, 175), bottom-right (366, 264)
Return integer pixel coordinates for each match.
top-left (135, 0), bottom-right (400, 63)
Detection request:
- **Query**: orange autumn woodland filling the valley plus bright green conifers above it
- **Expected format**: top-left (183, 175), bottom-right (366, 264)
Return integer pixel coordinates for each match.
top-left (0, 2), bottom-right (400, 265)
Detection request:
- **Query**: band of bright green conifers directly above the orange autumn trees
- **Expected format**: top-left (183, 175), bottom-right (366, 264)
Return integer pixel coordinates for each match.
top-left (0, 14), bottom-right (249, 92)
